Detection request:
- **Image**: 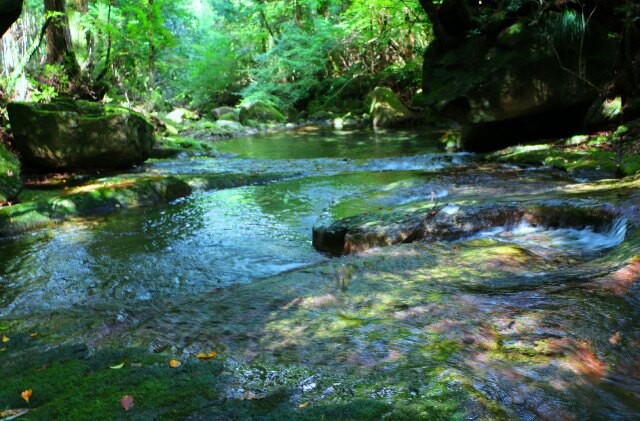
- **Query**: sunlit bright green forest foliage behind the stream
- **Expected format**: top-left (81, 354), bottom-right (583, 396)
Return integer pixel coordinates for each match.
top-left (0, 0), bottom-right (429, 118)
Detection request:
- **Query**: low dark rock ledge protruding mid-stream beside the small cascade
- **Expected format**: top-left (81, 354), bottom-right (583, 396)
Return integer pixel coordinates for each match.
top-left (313, 204), bottom-right (618, 256)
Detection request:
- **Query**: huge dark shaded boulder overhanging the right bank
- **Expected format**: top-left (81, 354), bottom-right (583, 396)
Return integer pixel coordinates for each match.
top-left (423, 17), bottom-right (618, 150)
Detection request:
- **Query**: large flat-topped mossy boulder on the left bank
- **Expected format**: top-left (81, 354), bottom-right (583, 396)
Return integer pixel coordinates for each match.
top-left (7, 101), bottom-right (155, 170)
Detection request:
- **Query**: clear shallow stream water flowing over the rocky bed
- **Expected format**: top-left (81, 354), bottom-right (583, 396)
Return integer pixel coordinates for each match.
top-left (0, 129), bottom-right (640, 419)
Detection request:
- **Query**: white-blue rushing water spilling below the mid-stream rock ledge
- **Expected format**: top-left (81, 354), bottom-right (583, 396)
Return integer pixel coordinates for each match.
top-left (471, 218), bottom-right (628, 254)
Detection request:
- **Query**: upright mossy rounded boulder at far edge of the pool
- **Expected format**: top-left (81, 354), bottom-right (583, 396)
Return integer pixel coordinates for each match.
top-left (365, 87), bottom-right (416, 128)
